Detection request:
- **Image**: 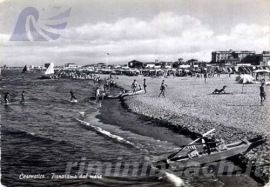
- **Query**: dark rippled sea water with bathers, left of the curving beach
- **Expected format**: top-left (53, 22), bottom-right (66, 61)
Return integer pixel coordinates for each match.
top-left (0, 71), bottom-right (256, 187)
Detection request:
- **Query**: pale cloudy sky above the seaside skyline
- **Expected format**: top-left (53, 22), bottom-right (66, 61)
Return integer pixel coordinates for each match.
top-left (0, 0), bottom-right (269, 66)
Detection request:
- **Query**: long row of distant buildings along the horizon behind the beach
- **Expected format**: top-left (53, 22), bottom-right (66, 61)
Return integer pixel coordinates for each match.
top-left (3, 50), bottom-right (270, 69)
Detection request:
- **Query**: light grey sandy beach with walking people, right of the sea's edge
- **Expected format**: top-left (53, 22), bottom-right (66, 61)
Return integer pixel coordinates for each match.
top-left (99, 75), bottom-right (270, 183)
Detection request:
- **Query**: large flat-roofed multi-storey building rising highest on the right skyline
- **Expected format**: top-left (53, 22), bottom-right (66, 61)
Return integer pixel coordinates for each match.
top-left (211, 50), bottom-right (255, 66)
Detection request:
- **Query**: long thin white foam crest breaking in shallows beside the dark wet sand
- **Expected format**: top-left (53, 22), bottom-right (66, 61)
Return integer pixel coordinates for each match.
top-left (75, 118), bottom-right (136, 147)
